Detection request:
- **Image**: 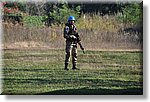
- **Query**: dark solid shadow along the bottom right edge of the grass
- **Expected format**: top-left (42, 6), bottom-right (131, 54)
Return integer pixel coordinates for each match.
top-left (37, 88), bottom-right (143, 95)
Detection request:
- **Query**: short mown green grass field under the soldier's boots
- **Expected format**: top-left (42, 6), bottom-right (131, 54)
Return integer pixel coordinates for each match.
top-left (2, 49), bottom-right (143, 95)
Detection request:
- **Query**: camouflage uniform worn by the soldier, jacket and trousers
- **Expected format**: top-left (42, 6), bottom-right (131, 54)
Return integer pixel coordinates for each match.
top-left (64, 23), bottom-right (77, 68)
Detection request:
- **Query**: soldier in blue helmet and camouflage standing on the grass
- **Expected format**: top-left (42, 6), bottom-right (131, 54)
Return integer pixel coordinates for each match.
top-left (64, 16), bottom-right (80, 70)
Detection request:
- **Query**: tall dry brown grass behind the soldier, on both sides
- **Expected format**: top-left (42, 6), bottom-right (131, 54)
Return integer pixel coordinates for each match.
top-left (3, 15), bottom-right (142, 49)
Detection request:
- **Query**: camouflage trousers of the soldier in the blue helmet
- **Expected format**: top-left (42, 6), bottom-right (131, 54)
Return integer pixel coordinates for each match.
top-left (65, 41), bottom-right (77, 65)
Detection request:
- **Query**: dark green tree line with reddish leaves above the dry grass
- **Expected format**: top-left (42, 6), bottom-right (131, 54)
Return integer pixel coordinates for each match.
top-left (2, 1), bottom-right (143, 26)
